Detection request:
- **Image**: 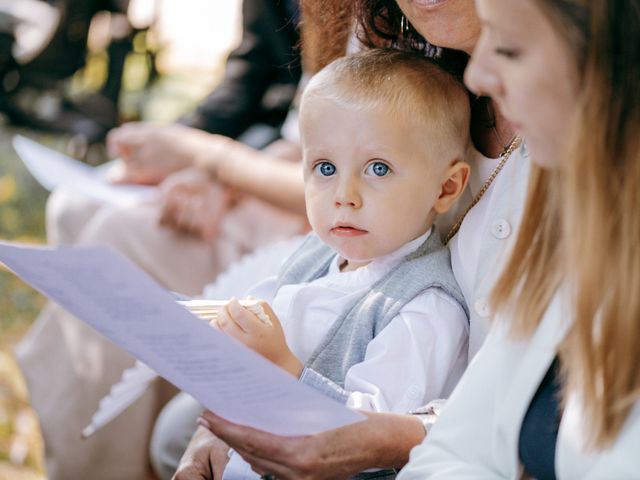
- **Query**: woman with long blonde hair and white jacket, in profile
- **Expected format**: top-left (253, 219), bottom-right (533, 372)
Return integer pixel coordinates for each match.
top-left (399, 0), bottom-right (640, 480)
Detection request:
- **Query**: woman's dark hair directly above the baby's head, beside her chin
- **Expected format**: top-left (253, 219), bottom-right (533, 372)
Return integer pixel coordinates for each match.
top-left (354, 0), bottom-right (469, 78)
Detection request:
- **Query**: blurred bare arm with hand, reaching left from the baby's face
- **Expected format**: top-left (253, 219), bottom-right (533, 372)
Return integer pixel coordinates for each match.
top-left (109, 123), bottom-right (305, 214)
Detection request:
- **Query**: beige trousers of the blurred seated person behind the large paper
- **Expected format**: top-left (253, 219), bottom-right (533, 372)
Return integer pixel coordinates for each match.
top-left (16, 191), bottom-right (306, 480)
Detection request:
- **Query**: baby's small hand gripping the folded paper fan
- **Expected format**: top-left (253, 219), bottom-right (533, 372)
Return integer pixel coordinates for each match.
top-left (217, 298), bottom-right (303, 377)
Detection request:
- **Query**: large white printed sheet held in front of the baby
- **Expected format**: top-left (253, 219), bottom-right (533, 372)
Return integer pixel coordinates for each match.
top-left (0, 242), bottom-right (364, 435)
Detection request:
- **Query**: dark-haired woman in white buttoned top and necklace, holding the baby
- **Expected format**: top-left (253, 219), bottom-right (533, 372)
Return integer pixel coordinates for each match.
top-left (171, 0), bottom-right (529, 479)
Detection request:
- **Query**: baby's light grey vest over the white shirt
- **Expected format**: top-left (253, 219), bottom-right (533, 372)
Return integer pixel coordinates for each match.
top-left (278, 231), bottom-right (469, 479)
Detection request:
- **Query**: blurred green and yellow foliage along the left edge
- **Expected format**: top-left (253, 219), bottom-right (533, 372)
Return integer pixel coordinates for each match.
top-left (0, 127), bottom-right (48, 480)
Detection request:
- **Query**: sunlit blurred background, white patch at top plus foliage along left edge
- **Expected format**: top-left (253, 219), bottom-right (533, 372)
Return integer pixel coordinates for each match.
top-left (0, 0), bottom-right (240, 480)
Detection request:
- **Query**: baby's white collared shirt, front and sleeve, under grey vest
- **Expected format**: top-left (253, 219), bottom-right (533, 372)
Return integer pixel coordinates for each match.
top-left (250, 232), bottom-right (468, 412)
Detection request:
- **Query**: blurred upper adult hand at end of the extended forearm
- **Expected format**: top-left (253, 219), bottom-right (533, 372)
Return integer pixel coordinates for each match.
top-left (107, 122), bottom-right (228, 185)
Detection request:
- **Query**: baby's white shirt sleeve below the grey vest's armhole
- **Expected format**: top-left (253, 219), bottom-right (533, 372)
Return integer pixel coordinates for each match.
top-left (345, 288), bottom-right (469, 413)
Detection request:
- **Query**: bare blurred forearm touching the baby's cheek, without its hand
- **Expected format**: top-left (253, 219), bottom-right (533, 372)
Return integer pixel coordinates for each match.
top-left (200, 142), bottom-right (306, 215)
